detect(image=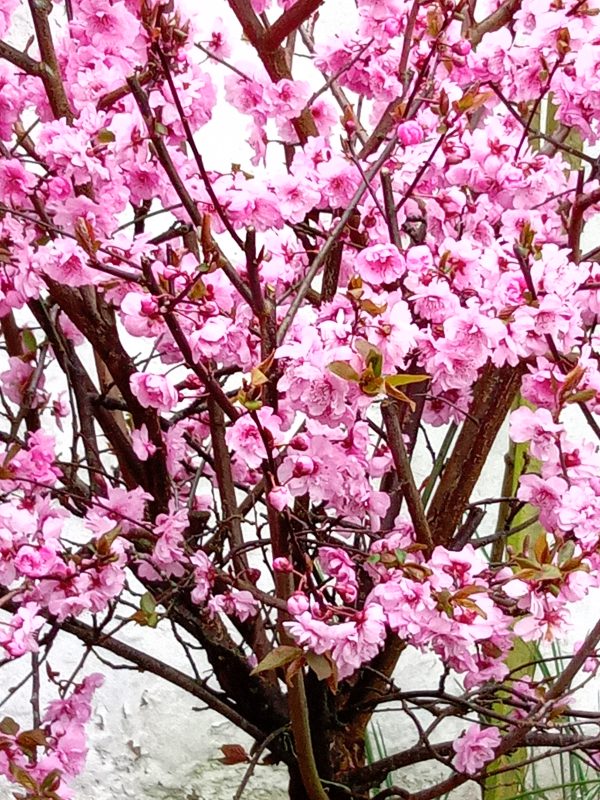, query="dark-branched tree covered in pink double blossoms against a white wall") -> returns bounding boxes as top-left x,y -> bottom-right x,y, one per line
0,0 -> 600,800
